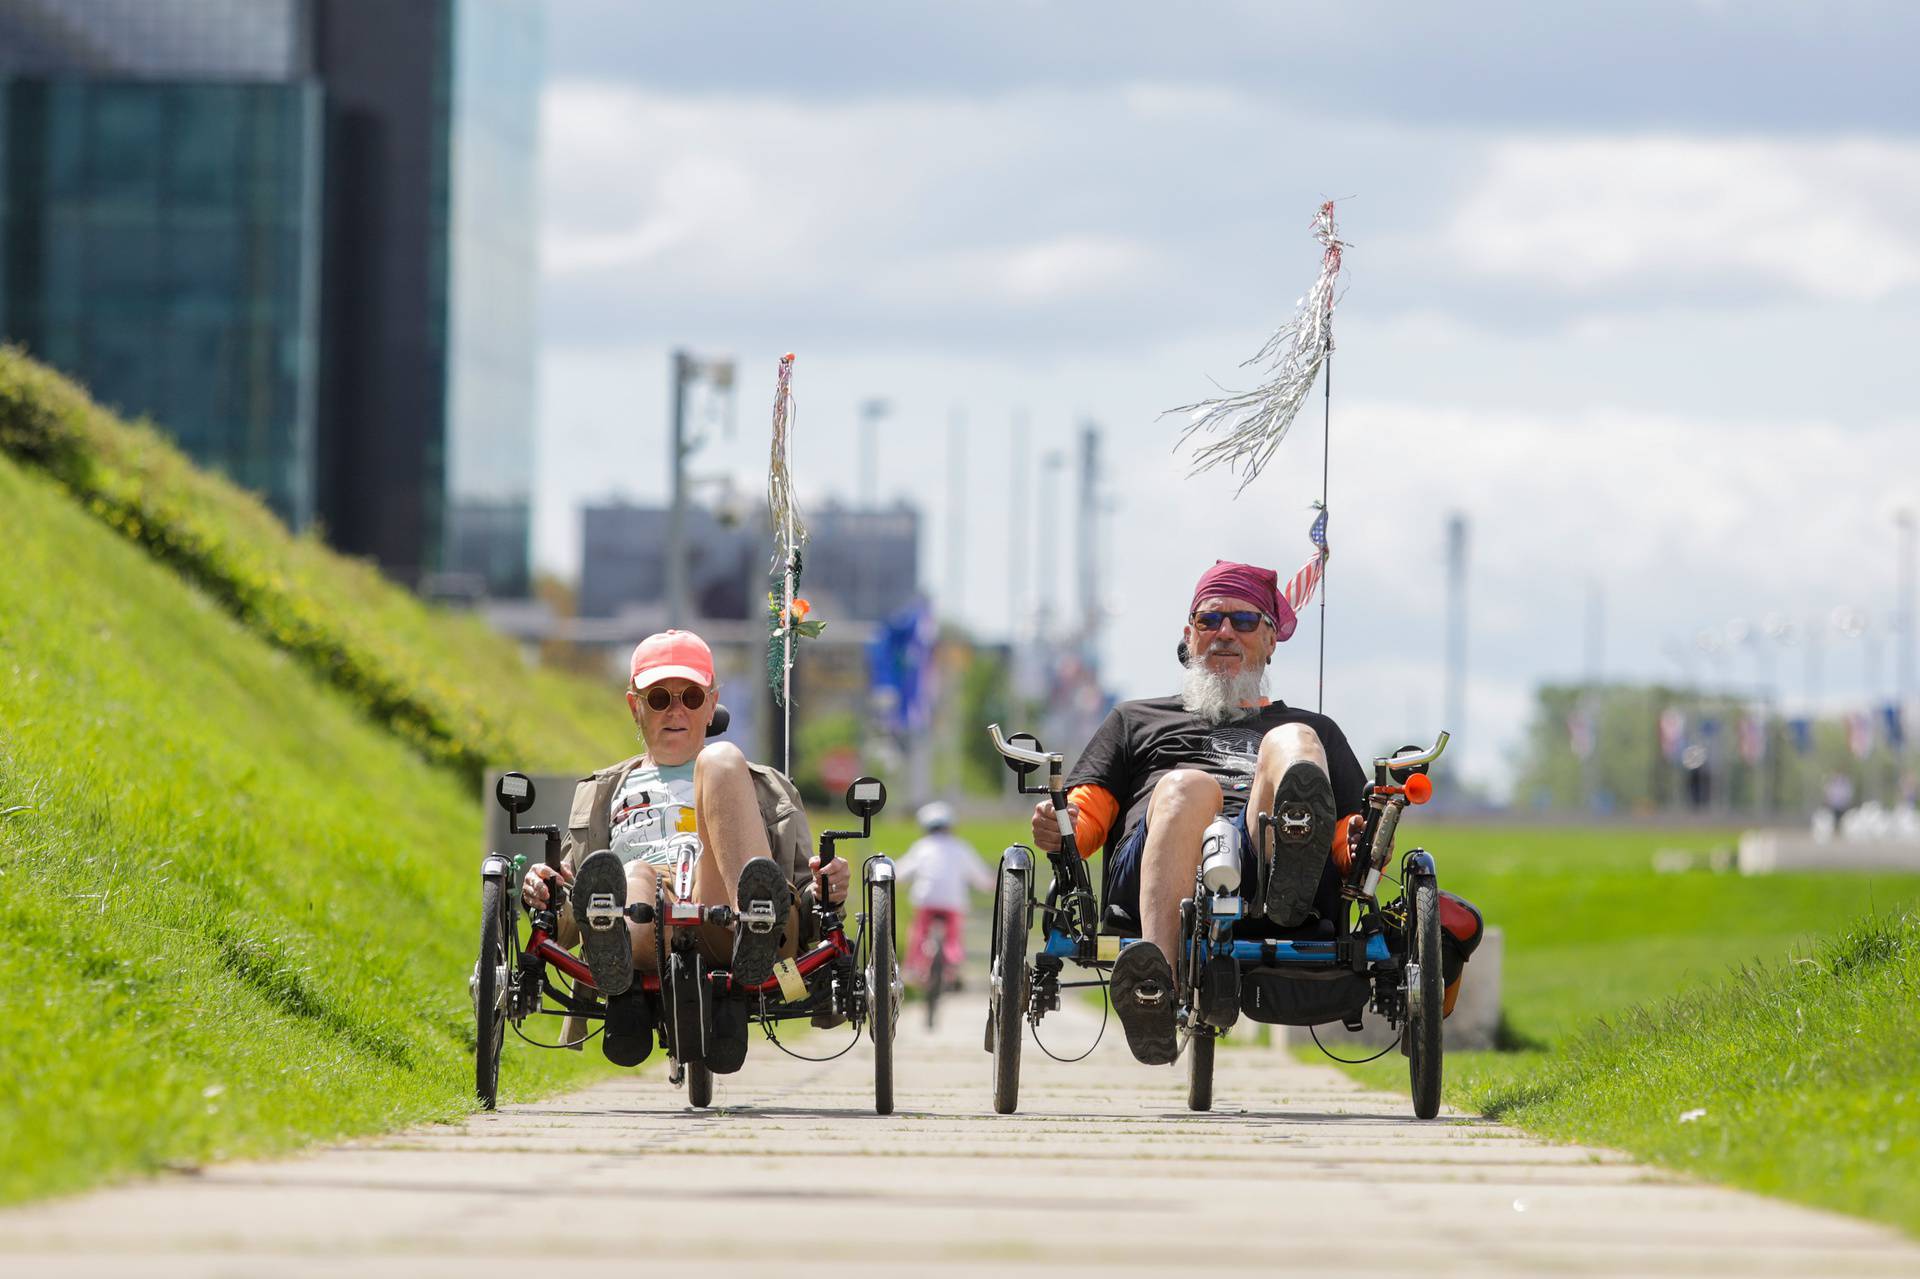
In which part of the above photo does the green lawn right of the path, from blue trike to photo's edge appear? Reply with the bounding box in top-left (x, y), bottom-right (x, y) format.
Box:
top-left (1309, 824), bottom-right (1920, 1231)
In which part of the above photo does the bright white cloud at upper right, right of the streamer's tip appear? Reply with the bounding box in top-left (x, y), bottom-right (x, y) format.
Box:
top-left (1440, 136), bottom-right (1920, 302)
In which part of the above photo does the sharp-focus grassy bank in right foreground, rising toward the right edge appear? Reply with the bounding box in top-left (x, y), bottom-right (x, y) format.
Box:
top-left (1463, 914), bottom-right (1920, 1233)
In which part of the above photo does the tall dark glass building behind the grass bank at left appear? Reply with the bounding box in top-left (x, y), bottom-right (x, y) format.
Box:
top-left (0, 0), bottom-right (541, 597)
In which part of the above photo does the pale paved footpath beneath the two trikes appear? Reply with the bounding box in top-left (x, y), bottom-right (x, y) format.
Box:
top-left (0, 1001), bottom-right (1920, 1279)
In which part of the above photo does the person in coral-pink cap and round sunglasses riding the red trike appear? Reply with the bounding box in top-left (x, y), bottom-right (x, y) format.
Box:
top-left (520, 630), bottom-right (849, 1074)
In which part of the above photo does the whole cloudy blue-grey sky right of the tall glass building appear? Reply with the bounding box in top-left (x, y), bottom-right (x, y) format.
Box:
top-left (536, 0), bottom-right (1920, 785)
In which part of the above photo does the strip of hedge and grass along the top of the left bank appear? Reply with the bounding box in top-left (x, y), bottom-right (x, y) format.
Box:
top-left (0, 348), bottom-right (618, 778)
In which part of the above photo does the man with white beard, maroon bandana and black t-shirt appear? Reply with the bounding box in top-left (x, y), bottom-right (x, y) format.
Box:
top-left (1033, 561), bottom-right (1367, 1064)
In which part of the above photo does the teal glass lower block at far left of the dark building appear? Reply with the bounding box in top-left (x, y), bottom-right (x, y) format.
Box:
top-left (0, 77), bottom-right (321, 528)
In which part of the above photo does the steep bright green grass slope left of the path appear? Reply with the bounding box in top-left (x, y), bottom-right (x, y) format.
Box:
top-left (0, 451), bottom-right (626, 1200)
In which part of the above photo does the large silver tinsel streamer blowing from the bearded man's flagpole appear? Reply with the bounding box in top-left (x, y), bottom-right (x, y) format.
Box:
top-left (1167, 200), bottom-right (1346, 495)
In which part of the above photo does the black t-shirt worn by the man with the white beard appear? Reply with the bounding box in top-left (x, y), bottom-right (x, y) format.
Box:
top-left (1068, 697), bottom-right (1367, 849)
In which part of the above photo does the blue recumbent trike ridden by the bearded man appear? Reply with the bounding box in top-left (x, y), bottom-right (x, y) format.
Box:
top-left (985, 724), bottom-right (1448, 1120)
